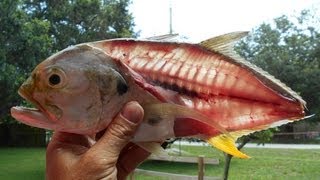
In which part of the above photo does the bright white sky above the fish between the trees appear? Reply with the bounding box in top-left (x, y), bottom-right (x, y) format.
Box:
top-left (129, 0), bottom-right (320, 42)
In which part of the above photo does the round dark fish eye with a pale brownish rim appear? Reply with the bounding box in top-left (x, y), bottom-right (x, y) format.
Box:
top-left (47, 68), bottom-right (66, 88)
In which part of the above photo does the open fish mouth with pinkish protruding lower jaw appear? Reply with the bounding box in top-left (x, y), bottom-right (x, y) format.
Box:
top-left (11, 85), bottom-right (56, 130)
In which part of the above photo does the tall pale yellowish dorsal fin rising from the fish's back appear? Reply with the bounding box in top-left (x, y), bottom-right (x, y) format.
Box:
top-left (200, 31), bottom-right (248, 55)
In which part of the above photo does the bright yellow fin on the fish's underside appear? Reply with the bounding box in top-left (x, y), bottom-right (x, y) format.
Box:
top-left (207, 134), bottom-right (250, 159)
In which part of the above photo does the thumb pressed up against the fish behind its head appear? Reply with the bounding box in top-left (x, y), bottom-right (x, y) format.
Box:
top-left (92, 102), bottom-right (144, 157)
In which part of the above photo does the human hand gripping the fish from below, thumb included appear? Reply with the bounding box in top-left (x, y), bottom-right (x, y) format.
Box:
top-left (46, 102), bottom-right (150, 180)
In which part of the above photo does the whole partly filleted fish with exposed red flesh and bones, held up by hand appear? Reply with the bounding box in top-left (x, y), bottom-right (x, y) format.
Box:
top-left (11, 32), bottom-right (306, 158)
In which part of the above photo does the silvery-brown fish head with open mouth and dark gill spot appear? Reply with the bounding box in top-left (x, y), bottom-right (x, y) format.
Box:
top-left (11, 45), bottom-right (126, 134)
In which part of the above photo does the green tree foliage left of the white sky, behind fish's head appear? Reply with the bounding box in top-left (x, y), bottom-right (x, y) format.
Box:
top-left (0, 0), bottom-right (137, 123)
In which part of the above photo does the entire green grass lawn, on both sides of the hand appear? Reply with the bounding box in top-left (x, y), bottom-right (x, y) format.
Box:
top-left (0, 146), bottom-right (320, 180)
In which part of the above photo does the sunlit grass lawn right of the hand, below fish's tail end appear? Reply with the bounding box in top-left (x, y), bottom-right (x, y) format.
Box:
top-left (140, 146), bottom-right (320, 180)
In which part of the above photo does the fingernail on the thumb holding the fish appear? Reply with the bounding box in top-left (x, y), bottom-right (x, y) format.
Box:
top-left (121, 102), bottom-right (143, 123)
